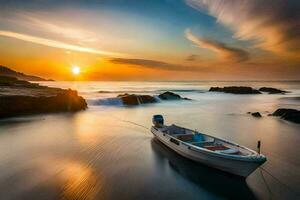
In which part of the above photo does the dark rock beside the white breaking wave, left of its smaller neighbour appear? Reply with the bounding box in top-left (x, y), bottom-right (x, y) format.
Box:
top-left (118, 93), bottom-right (157, 105)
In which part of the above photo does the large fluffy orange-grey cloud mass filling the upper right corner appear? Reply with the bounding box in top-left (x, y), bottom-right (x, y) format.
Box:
top-left (186, 0), bottom-right (300, 58)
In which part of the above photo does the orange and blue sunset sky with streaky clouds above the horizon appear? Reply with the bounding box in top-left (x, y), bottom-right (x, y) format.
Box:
top-left (0, 0), bottom-right (300, 81)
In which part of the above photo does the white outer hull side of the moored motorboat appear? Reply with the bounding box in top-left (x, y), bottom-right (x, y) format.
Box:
top-left (151, 128), bottom-right (265, 177)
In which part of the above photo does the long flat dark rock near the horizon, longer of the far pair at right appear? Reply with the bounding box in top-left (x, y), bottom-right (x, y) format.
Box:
top-left (209, 86), bottom-right (261, 94)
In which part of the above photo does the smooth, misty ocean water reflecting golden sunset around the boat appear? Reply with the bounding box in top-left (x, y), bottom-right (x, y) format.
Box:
top-left (0, 81), bottom-right (300, 199)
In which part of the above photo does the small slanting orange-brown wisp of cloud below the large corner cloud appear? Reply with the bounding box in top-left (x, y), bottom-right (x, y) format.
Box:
top-left (185, 29), bottom-right (249, 62)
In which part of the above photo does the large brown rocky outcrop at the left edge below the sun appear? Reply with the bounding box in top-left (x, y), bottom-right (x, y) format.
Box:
top-left (0, 77), bottom-right (87, 118)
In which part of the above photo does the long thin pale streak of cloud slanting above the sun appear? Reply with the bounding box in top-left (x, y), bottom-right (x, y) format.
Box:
top-left (0, 30), bottom-right (122, 56)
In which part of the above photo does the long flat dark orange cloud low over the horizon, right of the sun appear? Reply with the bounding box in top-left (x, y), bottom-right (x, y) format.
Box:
top-left (110, 58), bottom-right (209, 71)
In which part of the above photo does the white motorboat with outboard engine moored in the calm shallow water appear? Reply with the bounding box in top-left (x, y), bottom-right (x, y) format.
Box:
top-left (151, 115), bottom-right (267, 177)
